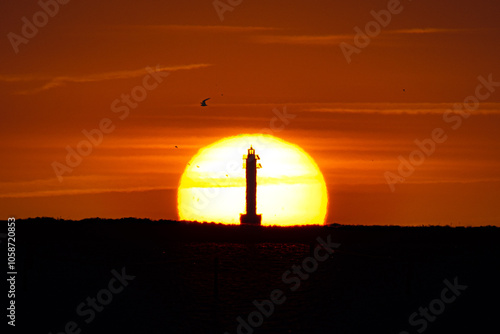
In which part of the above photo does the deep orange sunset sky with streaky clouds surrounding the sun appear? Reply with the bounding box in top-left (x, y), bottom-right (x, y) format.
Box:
top-left (0, 0), bottom-right (500, 226)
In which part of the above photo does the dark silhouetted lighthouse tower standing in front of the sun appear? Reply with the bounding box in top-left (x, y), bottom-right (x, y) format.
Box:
top-left (240, 146), bottom-right (262, 225)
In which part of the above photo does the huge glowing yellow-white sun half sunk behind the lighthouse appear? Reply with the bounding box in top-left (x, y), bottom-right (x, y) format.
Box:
top-left (177, 134), bottom-right (328, 226)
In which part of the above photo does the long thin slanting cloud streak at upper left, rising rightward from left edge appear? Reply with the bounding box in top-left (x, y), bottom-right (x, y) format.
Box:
top-left (0, 64), bottom-right (212, 95)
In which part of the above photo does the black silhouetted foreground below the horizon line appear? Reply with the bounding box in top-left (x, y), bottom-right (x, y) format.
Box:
top-left (2, 219), bottom-right (500, 334)
